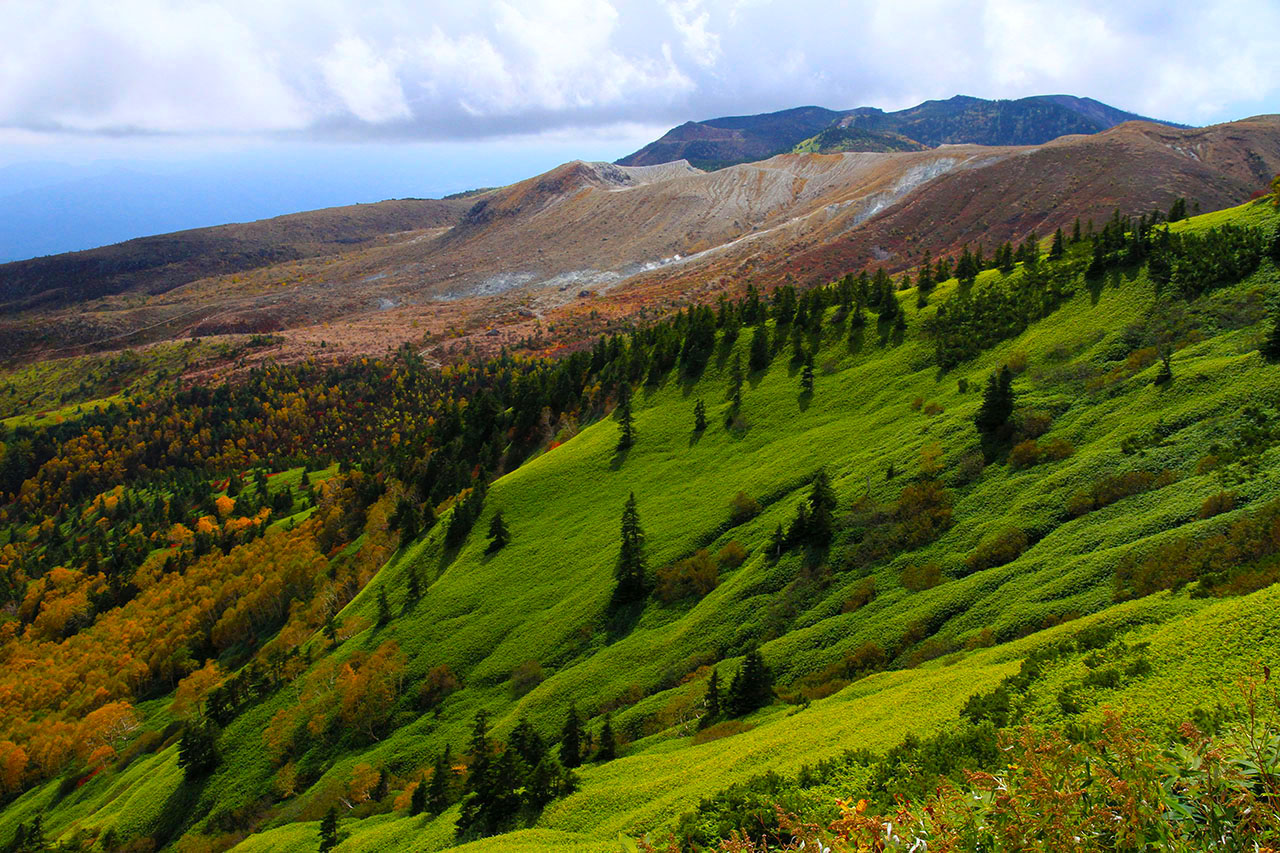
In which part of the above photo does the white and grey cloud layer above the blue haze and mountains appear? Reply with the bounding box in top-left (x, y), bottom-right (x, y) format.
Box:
top-left (0, 0), bottom-right (1280, 140)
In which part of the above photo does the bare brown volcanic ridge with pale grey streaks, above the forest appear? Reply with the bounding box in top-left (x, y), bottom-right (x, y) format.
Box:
top-left (0, 115), bottom-right (1280, 376)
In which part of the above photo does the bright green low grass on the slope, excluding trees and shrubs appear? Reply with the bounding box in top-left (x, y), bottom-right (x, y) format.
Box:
top-left (0, 199), bottom-right (1280, 850)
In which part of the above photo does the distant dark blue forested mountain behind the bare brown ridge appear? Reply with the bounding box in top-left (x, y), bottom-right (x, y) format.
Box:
top-left (618, 95), bottom-right (1177, 169)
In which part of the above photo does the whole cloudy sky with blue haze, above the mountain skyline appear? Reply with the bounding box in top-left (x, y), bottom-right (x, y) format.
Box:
top-left (0, 0), bottom-right (1280, 260)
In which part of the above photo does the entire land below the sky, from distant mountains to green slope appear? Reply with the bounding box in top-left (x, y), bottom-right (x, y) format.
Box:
top-left (0, 16), bottom-right (1280, 853)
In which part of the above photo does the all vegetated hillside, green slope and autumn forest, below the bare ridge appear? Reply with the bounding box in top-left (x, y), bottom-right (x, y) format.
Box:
top-left (0, 192), bottom-right (1280, 850)
